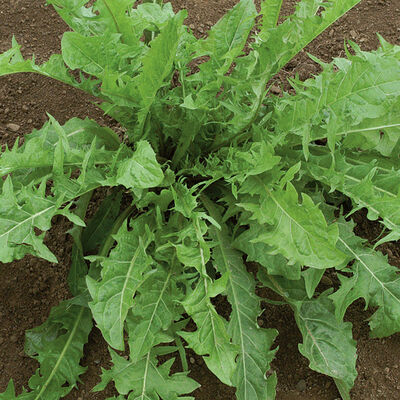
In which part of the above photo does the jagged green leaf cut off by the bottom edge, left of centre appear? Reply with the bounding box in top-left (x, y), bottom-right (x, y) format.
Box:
top-left (94, 348), bottom-right (199, 400)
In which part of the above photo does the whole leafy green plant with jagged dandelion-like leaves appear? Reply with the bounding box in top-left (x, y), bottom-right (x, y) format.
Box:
top-left (0, 0), bottom-right (400, 400)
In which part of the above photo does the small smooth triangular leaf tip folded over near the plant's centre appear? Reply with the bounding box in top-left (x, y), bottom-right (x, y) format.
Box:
top-left (116, 140), bottom-right (164, 189)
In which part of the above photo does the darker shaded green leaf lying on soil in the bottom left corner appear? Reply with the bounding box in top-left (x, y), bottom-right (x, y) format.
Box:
top-left (22, 301), bottom-right (92, 400)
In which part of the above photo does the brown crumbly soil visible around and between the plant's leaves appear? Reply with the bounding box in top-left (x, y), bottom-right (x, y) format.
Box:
top-left (0, 0), bottom-right (400, 400)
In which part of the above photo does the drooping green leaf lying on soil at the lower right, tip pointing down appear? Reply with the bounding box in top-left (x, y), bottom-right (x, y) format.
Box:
top-left (258, 270), bottom-right (357, 400)
